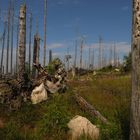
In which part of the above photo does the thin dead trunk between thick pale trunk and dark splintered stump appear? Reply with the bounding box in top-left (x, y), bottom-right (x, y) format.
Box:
top-left (29, 13), bottom-right (32, 73)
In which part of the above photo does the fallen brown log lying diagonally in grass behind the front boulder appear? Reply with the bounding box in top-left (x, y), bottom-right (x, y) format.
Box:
top-left (75, 94), bottom-right (109, 124)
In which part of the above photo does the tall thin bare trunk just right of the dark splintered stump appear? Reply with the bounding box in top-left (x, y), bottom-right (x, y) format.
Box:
top-left (43, 0), bottom-right (47, 66)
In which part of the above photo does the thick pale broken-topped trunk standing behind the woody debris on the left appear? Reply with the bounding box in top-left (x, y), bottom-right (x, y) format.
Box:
top-left (18, 5), bottom-right (26, 80)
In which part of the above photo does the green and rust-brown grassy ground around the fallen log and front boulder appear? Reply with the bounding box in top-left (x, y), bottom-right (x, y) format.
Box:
top-left (0, 73), bottom-right (131, 140)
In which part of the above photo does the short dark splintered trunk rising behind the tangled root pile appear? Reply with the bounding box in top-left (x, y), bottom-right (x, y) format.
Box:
top-left (32, 34), bottom-right (40, 78)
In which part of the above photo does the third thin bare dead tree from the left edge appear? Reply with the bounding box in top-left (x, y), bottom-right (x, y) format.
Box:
top-left (11, 2), bottom-right (14, 74)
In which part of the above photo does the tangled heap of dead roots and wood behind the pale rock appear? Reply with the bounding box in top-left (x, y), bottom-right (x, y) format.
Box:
top-left (0, 60), bottom-right (67, 110)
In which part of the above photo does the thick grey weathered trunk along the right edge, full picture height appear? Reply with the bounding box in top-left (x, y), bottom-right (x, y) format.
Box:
top-left (130, 0), bottom-right (140, 140)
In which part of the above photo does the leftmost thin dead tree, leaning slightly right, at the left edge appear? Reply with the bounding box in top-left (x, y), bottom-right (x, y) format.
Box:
top-left (1, 22), bottom-right (6, 74)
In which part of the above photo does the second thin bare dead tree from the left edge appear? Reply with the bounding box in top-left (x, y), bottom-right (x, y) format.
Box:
top-left (6, 2), bottom-right (11, 74)
